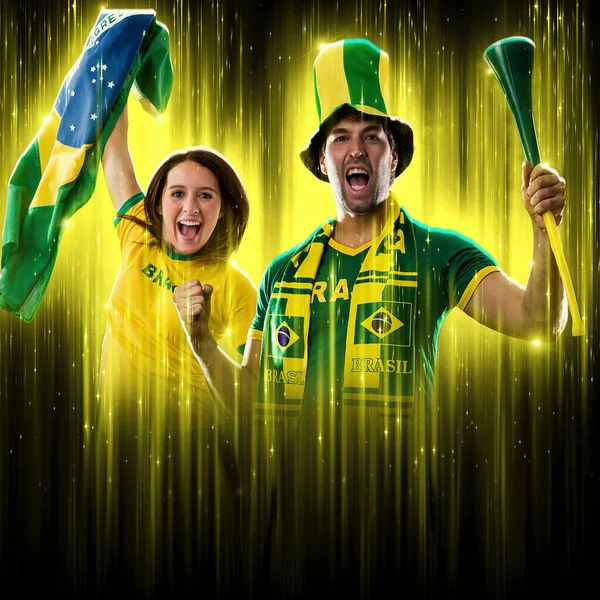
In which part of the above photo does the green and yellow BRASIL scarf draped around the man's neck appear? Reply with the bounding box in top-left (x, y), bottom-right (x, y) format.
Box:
top-left (256, 194), bottom-right (417, 422)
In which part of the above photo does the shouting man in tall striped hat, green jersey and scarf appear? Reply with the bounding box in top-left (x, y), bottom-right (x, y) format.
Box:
top-left (174, 40), bottom-right (567, 424)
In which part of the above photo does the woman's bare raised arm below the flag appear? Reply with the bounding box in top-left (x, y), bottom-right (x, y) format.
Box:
top-left (102, 106), bottom-right (142, 212)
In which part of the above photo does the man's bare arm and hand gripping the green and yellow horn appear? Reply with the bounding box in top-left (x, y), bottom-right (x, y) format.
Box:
top-left (465, 162), bottom-right (567, 341)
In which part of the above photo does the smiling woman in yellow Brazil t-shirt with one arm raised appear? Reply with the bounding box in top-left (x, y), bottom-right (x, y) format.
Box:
top-left (100, 108), bottom-right (256, 433)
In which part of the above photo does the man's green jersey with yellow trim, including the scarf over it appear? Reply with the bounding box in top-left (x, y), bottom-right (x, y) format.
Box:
top-left (250, 196), bottom-right (498, 422)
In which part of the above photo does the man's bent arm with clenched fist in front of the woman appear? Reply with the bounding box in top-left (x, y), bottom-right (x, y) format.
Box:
top-left (173, 279), bottom-right (262, 422)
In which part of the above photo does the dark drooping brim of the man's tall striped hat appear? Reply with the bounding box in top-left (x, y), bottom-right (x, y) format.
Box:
top-left (300, 105), bottom-right (415, 181)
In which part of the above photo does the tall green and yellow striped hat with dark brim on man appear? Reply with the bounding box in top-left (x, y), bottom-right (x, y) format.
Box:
top-left (300, 38), bottom-right (414, 181)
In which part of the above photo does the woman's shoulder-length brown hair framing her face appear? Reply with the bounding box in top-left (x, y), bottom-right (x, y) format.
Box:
top-left (117, 146), bottom-right (250, 262)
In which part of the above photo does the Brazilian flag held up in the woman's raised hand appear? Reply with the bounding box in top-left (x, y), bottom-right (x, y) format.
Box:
top-left (0, 9), bottom-right (173, 323)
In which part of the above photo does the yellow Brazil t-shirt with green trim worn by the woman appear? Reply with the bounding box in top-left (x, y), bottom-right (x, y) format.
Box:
top-left (99, 193), bottom-right (257, 433)
